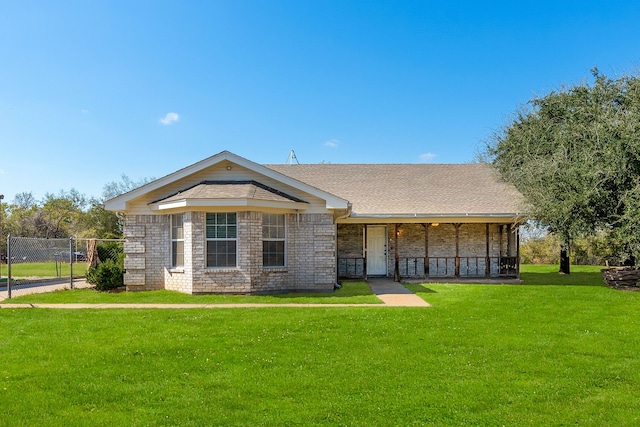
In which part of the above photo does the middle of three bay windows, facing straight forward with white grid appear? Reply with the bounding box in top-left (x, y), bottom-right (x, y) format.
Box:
top-left (206, 213), bottom-right (238, 267)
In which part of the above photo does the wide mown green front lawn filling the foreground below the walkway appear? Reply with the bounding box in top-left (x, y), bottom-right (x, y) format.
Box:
top-left (0, 268), bottom-right (640, 426)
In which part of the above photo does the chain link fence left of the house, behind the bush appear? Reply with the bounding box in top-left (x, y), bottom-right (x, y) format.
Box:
top-left (0, 236), bottom-right (124, 298)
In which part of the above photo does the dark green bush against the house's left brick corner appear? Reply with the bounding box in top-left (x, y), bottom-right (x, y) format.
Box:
top-left (87, 242), bottom-right (124, 291)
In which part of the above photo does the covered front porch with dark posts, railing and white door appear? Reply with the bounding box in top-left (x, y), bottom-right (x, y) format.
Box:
top-left (337, 222), bottom-right (520, 281)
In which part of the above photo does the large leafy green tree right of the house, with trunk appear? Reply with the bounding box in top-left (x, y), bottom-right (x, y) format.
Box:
top-left (483, 69), bottom-right (640, 273)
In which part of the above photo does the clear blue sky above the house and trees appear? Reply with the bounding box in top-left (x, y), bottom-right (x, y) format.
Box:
top-left (0, 0), bottom-right (640, 202)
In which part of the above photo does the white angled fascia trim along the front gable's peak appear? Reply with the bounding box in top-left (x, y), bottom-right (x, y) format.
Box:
top-left (104, 151), bottom-right (349, 211)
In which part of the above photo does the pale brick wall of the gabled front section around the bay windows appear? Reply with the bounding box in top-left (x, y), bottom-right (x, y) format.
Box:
top-left (125, 211), bottom-right (336, 293)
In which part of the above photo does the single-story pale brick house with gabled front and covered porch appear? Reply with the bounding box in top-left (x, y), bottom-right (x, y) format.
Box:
top-left (105, 151), bottom-right (522, 294)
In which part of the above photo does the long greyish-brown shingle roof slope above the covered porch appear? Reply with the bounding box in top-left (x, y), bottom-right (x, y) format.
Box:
top-left (266, 163), bottom-right (523, 216)
